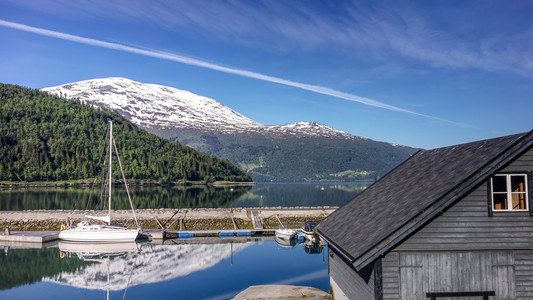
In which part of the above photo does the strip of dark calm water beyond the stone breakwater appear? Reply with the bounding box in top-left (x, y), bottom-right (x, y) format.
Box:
top-left (0, 183), bottom-right (369, 210)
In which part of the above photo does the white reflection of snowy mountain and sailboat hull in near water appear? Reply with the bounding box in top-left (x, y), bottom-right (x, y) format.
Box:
top-left (43, 242), bottom-right (252, 291)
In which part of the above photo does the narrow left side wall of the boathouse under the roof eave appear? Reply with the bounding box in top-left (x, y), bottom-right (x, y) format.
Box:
top-left (328, 248), bottom-right (374, 299)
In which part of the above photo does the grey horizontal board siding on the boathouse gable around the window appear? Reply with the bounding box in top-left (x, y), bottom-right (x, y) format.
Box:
top-left (396, 146), bottom-right (533, 251)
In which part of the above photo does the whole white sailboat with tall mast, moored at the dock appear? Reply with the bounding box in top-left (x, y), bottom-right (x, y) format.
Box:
top-left (59, 121), bottom-right (140, 243)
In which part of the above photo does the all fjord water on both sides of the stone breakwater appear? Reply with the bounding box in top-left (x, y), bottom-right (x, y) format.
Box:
top-left (0, 183), bottom-right (354, 299)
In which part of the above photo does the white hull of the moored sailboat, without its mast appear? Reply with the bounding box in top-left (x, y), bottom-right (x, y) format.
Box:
top-left (59, 226), bottom-right (139, 243)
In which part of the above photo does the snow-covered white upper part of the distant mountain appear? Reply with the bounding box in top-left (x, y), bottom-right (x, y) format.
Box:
top-left (42, 77), bottom-right (360, 139)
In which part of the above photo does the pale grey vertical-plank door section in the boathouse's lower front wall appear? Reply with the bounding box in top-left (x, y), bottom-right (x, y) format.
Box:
top-left (400, 251), bottom-right (516, 299)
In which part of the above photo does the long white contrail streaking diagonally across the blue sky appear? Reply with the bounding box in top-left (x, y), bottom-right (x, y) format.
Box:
top-left (0, 19), bottom-right (469, 127)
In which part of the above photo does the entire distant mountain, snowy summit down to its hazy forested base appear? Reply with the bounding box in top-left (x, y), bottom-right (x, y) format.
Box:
top-left (42, 77), bottom-right (417, 181)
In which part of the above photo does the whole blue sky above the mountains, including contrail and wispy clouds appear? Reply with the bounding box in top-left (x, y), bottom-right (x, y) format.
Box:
top-left (0, 0), bottom-right (533, 149)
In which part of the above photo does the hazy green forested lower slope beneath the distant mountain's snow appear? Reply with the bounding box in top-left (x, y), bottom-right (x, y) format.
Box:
top-left (172, 131), bottom-right (417, 181)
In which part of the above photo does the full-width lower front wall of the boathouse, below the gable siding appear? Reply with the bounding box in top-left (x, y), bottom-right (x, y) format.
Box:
top-left (382, 250), bottom-right (533, 300)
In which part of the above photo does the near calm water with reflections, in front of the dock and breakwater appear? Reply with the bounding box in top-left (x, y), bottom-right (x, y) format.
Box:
top-left (0, 238), bottom-right (329, 299)
